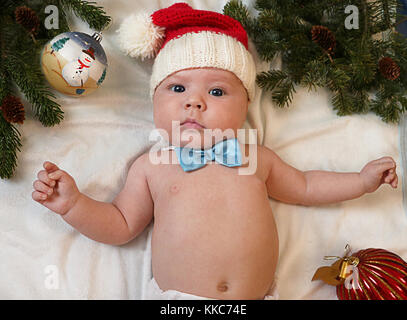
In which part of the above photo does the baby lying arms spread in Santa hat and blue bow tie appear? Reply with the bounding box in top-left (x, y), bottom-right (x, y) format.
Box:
top-left (32, 4), bottom-right (398, 299)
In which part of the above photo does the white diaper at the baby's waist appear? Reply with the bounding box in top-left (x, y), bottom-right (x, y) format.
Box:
top-left (144, 278), bottom-right (278, 300)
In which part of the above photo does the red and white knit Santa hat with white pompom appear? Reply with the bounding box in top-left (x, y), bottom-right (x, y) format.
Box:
top-left (118, 3), bottom-right (256, 101)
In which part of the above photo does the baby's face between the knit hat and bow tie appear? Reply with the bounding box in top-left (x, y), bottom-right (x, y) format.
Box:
top-left (153, 68), bottom-right (248, 148)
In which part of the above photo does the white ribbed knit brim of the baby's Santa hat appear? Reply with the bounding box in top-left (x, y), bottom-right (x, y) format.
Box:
top-left (150, 31), bottom-right (256, 101)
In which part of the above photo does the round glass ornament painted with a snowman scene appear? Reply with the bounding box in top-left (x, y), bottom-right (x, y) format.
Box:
top-left (41, 32), bottom-right (107, 96)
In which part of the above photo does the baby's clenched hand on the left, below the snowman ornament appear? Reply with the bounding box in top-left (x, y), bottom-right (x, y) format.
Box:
top-left (32, 161), bottom-right (80, 215)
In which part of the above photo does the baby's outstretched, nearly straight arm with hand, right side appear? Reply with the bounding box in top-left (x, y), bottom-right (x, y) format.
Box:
top-left (264, 148), bottom-right (398, 205)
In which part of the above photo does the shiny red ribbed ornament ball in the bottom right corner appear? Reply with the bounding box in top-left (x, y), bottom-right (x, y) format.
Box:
top-left (336, 248), bottom-right (407, 300)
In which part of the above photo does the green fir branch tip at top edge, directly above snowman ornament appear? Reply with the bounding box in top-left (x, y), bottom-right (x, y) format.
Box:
top-left (59, 0), bottom-right (112, 31)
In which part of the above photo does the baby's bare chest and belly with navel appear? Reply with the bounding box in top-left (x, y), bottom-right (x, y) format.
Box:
top-left (152, 171), bottom-right (278, 299)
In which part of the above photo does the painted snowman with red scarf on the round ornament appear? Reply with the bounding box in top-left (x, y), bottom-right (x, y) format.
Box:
top-left (62, 47), bottom-right (95, 87)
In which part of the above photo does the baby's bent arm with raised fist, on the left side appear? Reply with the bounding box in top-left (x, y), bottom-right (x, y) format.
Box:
top-left (32, 156), bottom-right (153, 245)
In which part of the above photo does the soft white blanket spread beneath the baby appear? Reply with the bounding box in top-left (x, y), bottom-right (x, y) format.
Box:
top-left (0, 0), bottom-right (407, 299)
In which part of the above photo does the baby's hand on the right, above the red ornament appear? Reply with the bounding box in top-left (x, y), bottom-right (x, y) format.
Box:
top-left (360, 157), bottom-right (398, 193)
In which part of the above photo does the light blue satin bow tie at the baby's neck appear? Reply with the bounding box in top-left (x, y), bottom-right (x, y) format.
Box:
top-left (175, 138), bottom-right (242, 171)
